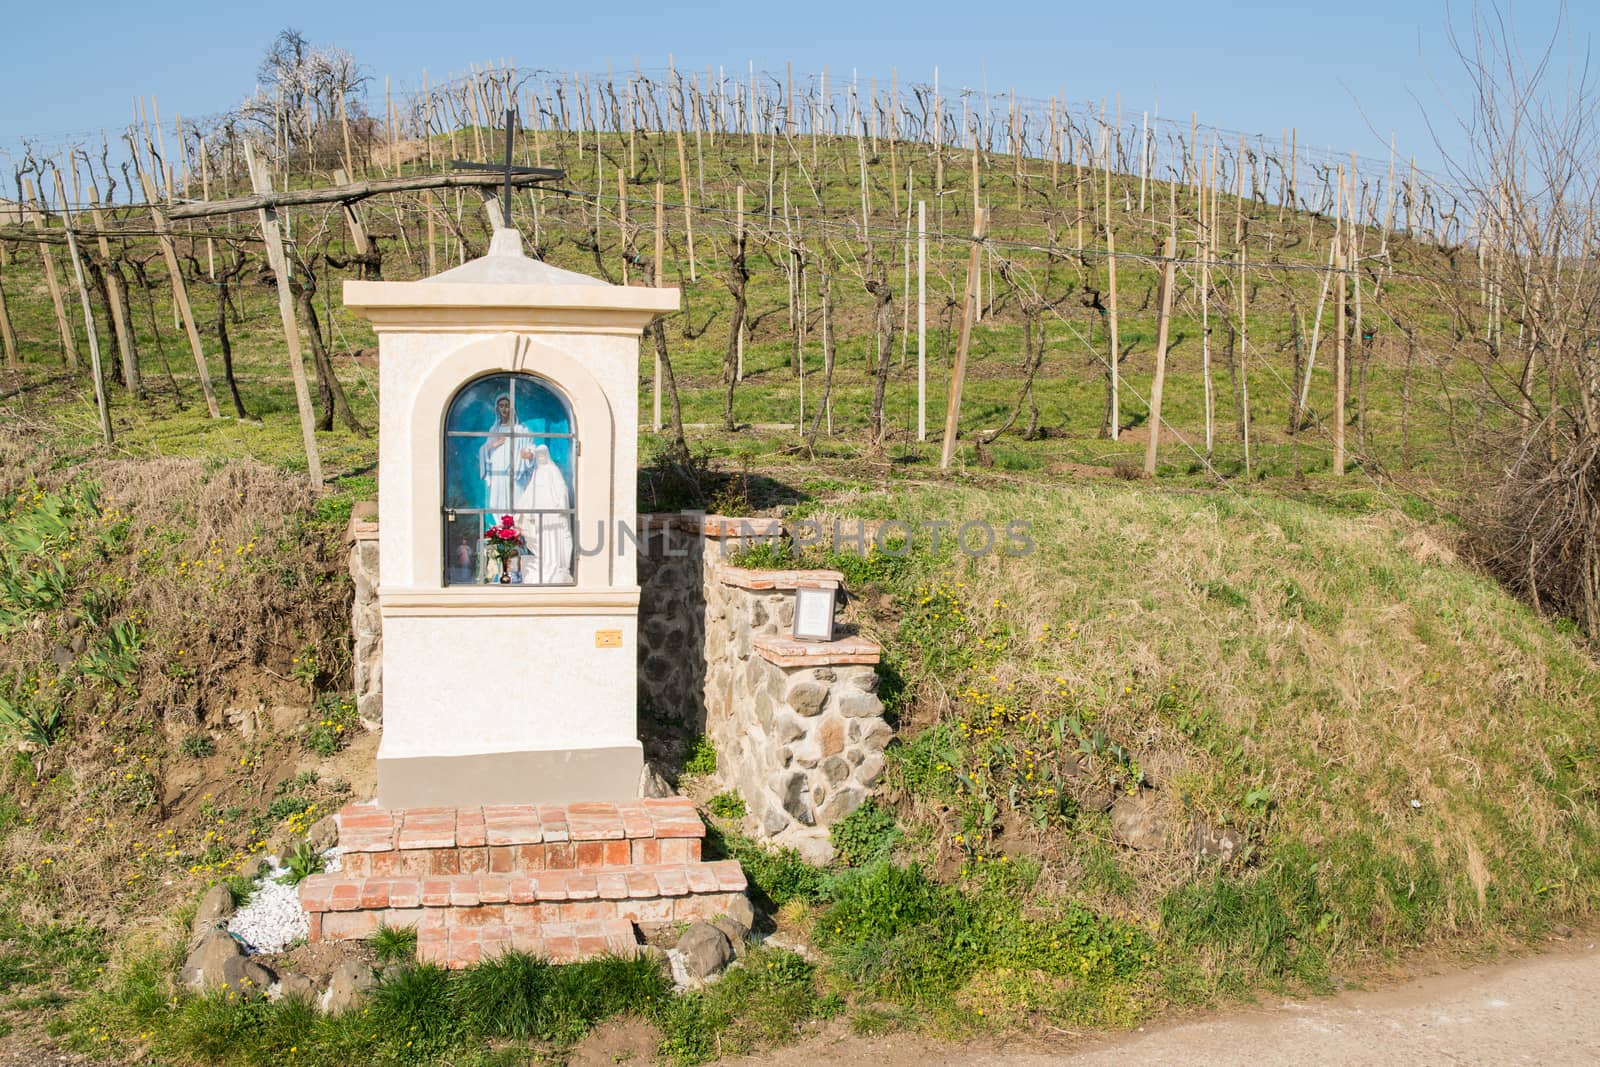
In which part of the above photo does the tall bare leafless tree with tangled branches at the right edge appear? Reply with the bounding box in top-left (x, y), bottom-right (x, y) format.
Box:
top-left (1437, 8), bottom-right (1600, 638)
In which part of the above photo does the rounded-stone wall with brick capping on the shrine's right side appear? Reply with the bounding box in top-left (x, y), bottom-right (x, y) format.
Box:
top-left (638, 515), bottom-right (893, 859)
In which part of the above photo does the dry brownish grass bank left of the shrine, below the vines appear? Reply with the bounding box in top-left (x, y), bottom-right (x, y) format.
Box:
top-left (0, 425), bottom-right (349, 925)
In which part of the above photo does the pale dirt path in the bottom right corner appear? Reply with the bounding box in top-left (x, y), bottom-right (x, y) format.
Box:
top-left (736, 939), bottom-right (1600, 1067)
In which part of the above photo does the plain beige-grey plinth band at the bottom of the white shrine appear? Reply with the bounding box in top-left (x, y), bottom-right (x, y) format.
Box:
top-left (378, 741), bottom-right (645, 808)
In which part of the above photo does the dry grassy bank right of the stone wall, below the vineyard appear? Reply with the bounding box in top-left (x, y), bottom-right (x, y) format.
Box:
top-left (806, 483), bottom-right (1600, 979)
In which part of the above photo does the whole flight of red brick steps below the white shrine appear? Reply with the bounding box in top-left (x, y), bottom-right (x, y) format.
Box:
top-left (299, 797), bottom-right (746, 968)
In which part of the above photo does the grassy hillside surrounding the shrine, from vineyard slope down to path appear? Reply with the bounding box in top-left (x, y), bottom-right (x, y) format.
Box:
top-left (0, 119), bottom-right (1600, 1062)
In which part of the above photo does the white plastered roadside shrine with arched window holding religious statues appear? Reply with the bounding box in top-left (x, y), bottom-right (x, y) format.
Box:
top-left (344, 230), bottom-right (678, 809)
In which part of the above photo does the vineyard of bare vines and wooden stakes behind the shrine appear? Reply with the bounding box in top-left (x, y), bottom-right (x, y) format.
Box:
top-left (0, 55), bottom-right (1523, 492)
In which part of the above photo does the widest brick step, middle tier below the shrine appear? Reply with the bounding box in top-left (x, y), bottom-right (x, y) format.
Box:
top-left (299, 861), bottom-right (746, 941)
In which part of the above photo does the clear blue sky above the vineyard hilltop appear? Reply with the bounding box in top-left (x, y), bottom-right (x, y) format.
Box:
top-left (0, 0), bottom-right (1600, 177)
